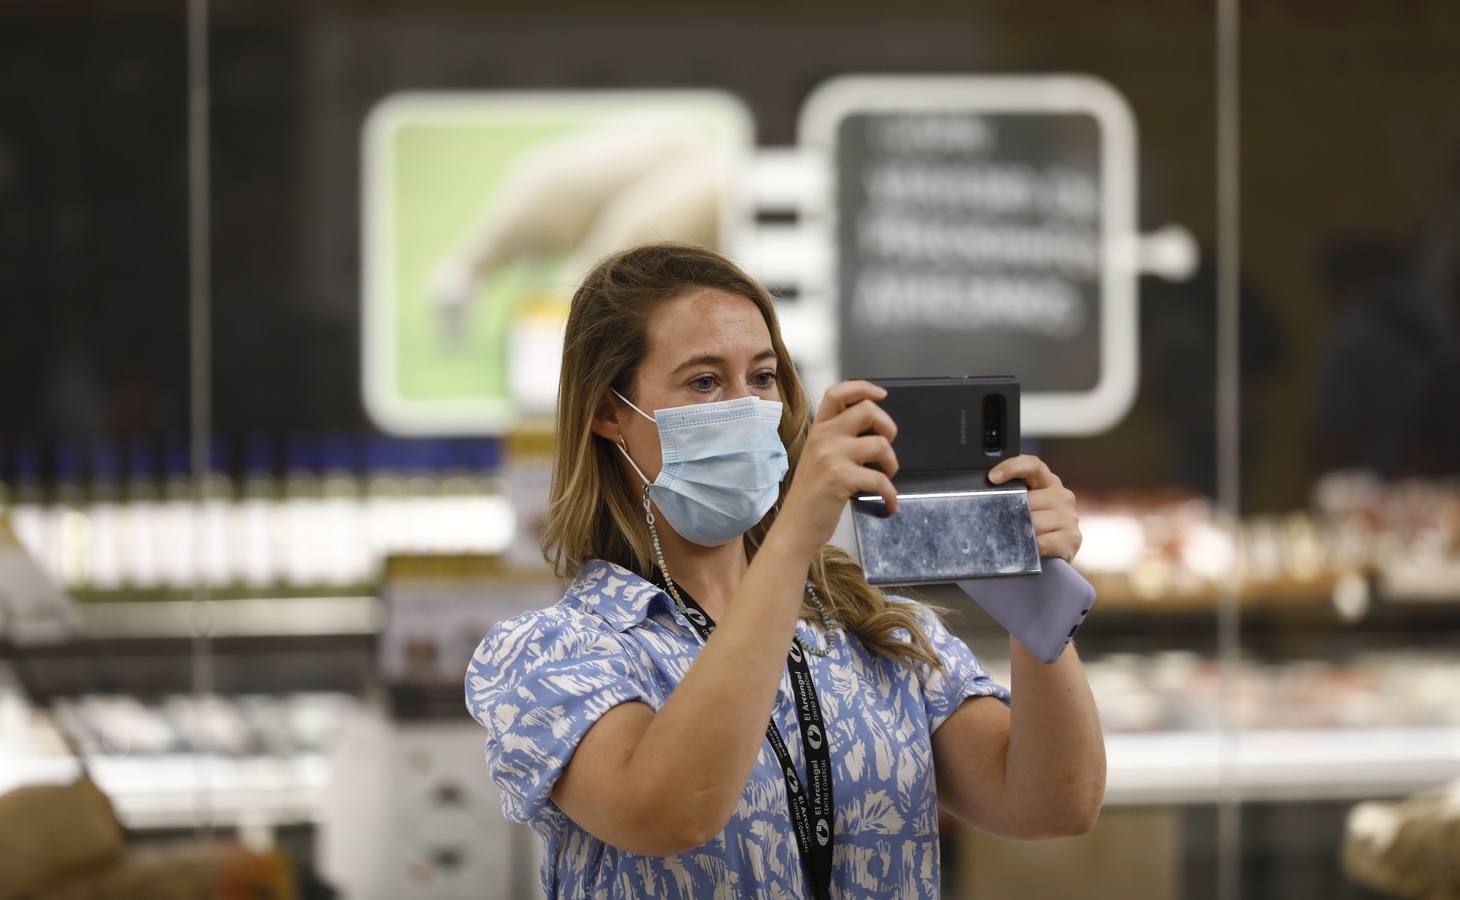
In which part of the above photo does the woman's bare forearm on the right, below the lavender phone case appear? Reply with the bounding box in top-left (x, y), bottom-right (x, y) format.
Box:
top-left (1004, 637), bottom-right (1105, 833)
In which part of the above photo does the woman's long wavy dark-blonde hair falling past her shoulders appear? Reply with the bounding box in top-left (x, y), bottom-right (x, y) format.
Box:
top-left (542, 243), bottom-right (942, 668)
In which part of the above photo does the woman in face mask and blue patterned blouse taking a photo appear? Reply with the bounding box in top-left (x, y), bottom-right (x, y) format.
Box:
top-left (466, 244), bottom-right (1105, 899)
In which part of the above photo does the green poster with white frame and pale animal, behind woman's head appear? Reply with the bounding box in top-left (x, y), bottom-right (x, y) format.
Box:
top-left (362, 91), bottom-right (752, 434)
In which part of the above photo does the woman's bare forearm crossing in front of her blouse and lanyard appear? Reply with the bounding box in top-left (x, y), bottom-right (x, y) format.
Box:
top-left (629, 529), bottom-right (810, 843)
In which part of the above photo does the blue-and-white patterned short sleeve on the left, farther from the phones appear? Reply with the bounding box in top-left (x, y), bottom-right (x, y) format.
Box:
top-left (466, 603), bottom-right (648, 823)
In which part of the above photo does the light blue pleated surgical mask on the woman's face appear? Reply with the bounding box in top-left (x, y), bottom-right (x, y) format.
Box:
top-left (613, 390), bottom-right (788, 546)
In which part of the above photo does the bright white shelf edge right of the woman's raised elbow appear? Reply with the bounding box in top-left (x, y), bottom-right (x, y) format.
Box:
top-left (1105, 728), bottom-right (1460, 806)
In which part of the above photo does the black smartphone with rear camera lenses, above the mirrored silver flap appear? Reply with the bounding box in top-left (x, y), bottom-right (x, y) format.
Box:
top-left (869, 375), bottom-right (1019, 473)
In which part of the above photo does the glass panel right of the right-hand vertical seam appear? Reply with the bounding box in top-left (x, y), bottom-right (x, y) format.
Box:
top-left (1234, 4), bottom-right (1460, 896)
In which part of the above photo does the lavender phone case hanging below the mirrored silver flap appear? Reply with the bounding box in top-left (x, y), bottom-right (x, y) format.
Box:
top-left (958, 557), bottom-right (1095, 663)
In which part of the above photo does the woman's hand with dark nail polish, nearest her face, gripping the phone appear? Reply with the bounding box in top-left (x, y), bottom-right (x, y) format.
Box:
top-left (772, 381), bottom-right (898, 551)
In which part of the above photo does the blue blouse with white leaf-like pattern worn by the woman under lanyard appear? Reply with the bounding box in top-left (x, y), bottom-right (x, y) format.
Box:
top-left (466, 560), bottom-right (1009, 900)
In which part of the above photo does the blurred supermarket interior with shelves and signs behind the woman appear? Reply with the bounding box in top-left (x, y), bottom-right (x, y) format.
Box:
top-left (0, 0), bottom-right (1460, 900)
